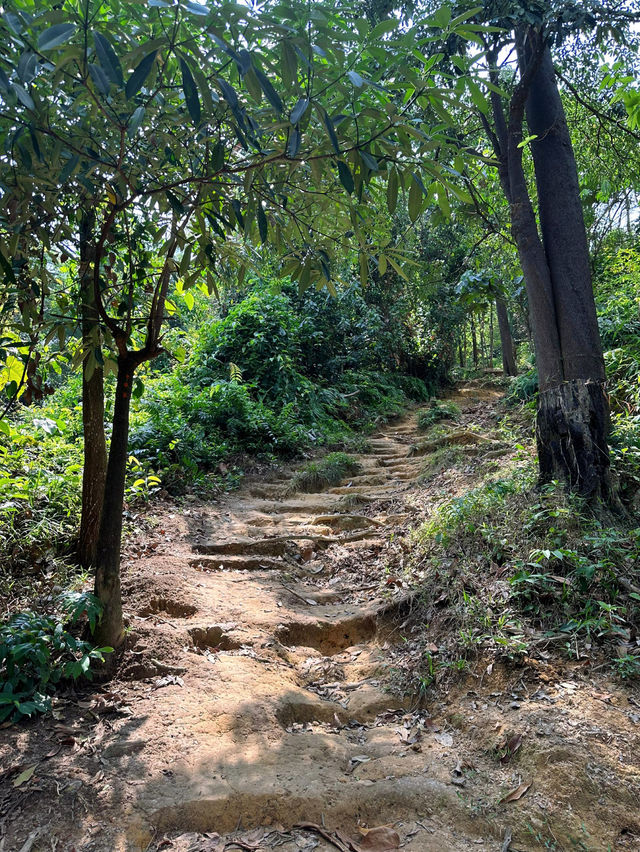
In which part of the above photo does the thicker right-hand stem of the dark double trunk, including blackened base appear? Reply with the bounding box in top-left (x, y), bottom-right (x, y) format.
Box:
top-left (518, 27), bottom-right (615, 500)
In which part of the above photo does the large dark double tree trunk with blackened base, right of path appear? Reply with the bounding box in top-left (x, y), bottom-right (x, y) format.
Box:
top-left (485, 33), bottom-right (617, 505)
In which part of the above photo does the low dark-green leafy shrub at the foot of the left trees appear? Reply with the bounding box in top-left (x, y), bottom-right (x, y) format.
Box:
top-left (0, 592), bottom-right (113, 721)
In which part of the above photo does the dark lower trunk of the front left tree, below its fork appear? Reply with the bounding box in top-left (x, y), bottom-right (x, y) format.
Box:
top-left (95, 356), bottom-right (136, 648)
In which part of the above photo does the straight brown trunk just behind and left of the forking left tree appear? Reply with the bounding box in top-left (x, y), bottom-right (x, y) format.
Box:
top-left (78, 211), bottom-right (107, 568)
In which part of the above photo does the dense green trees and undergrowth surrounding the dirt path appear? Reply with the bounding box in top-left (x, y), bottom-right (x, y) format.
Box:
top-left (0, 2), bottom-right (640, 715)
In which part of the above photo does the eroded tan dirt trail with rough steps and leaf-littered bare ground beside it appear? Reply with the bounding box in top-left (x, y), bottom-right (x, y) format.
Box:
top-left (0, 383), bottom-right (640, 852)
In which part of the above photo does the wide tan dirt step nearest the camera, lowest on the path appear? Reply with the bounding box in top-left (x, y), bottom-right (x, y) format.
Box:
top-left (147, 776), bottom-right (478, 852)
